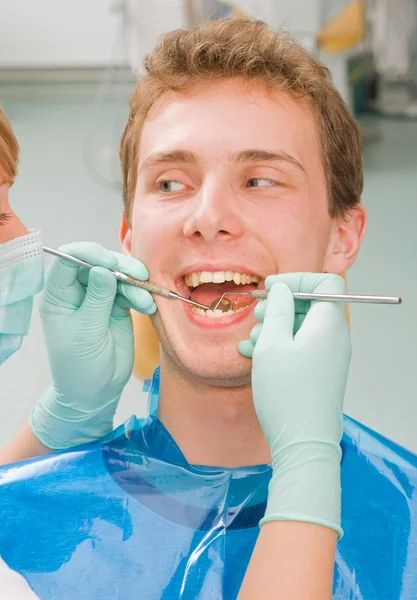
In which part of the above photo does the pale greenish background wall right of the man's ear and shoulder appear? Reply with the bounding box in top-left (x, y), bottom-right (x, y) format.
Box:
top-left (345, 119), bottom-right (417, 452)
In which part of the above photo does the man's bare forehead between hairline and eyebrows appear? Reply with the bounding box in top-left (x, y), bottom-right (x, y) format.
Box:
top-left (139, 80), bottom-right (321, 167)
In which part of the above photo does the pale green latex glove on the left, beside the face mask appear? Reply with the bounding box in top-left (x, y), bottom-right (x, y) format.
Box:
top-left (30, 242), bottom-right (156, 449)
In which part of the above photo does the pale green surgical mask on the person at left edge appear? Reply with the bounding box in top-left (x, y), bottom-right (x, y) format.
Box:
top-left (0, 231), bottom-right (43, 365)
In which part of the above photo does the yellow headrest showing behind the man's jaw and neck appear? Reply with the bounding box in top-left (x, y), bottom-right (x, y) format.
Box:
top-left (132, 275), bottom-right (350, 381)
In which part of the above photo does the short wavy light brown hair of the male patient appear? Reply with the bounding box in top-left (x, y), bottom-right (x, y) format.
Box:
top-left (120, 19), bottom-right (363, 218)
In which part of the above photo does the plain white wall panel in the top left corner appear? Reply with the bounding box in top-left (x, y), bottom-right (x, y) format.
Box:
top-left (0, 0), bottom-right (126, 68)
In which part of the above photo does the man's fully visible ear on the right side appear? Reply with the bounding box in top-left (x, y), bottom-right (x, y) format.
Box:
top-left (323, 205), bottom-right (367, 274)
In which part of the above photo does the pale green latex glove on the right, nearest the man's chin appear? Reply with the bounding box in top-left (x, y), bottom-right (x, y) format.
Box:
top-left (237, 273), bottom-right (351, 537)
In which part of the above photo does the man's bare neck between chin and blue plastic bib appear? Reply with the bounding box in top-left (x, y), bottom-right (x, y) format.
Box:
top-left (158, 360), bottom-right (271, 468)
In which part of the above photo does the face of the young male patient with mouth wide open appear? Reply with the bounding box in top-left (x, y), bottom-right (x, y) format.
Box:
top-left (124, 80), bottom-right (359, 386)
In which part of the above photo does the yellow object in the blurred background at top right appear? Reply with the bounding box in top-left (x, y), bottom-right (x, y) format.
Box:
top-left (317, 1), bottom-right (365, 54)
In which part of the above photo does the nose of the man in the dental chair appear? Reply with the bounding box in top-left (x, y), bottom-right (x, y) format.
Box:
top-left (183, 183), bottom-right (244, 244)
